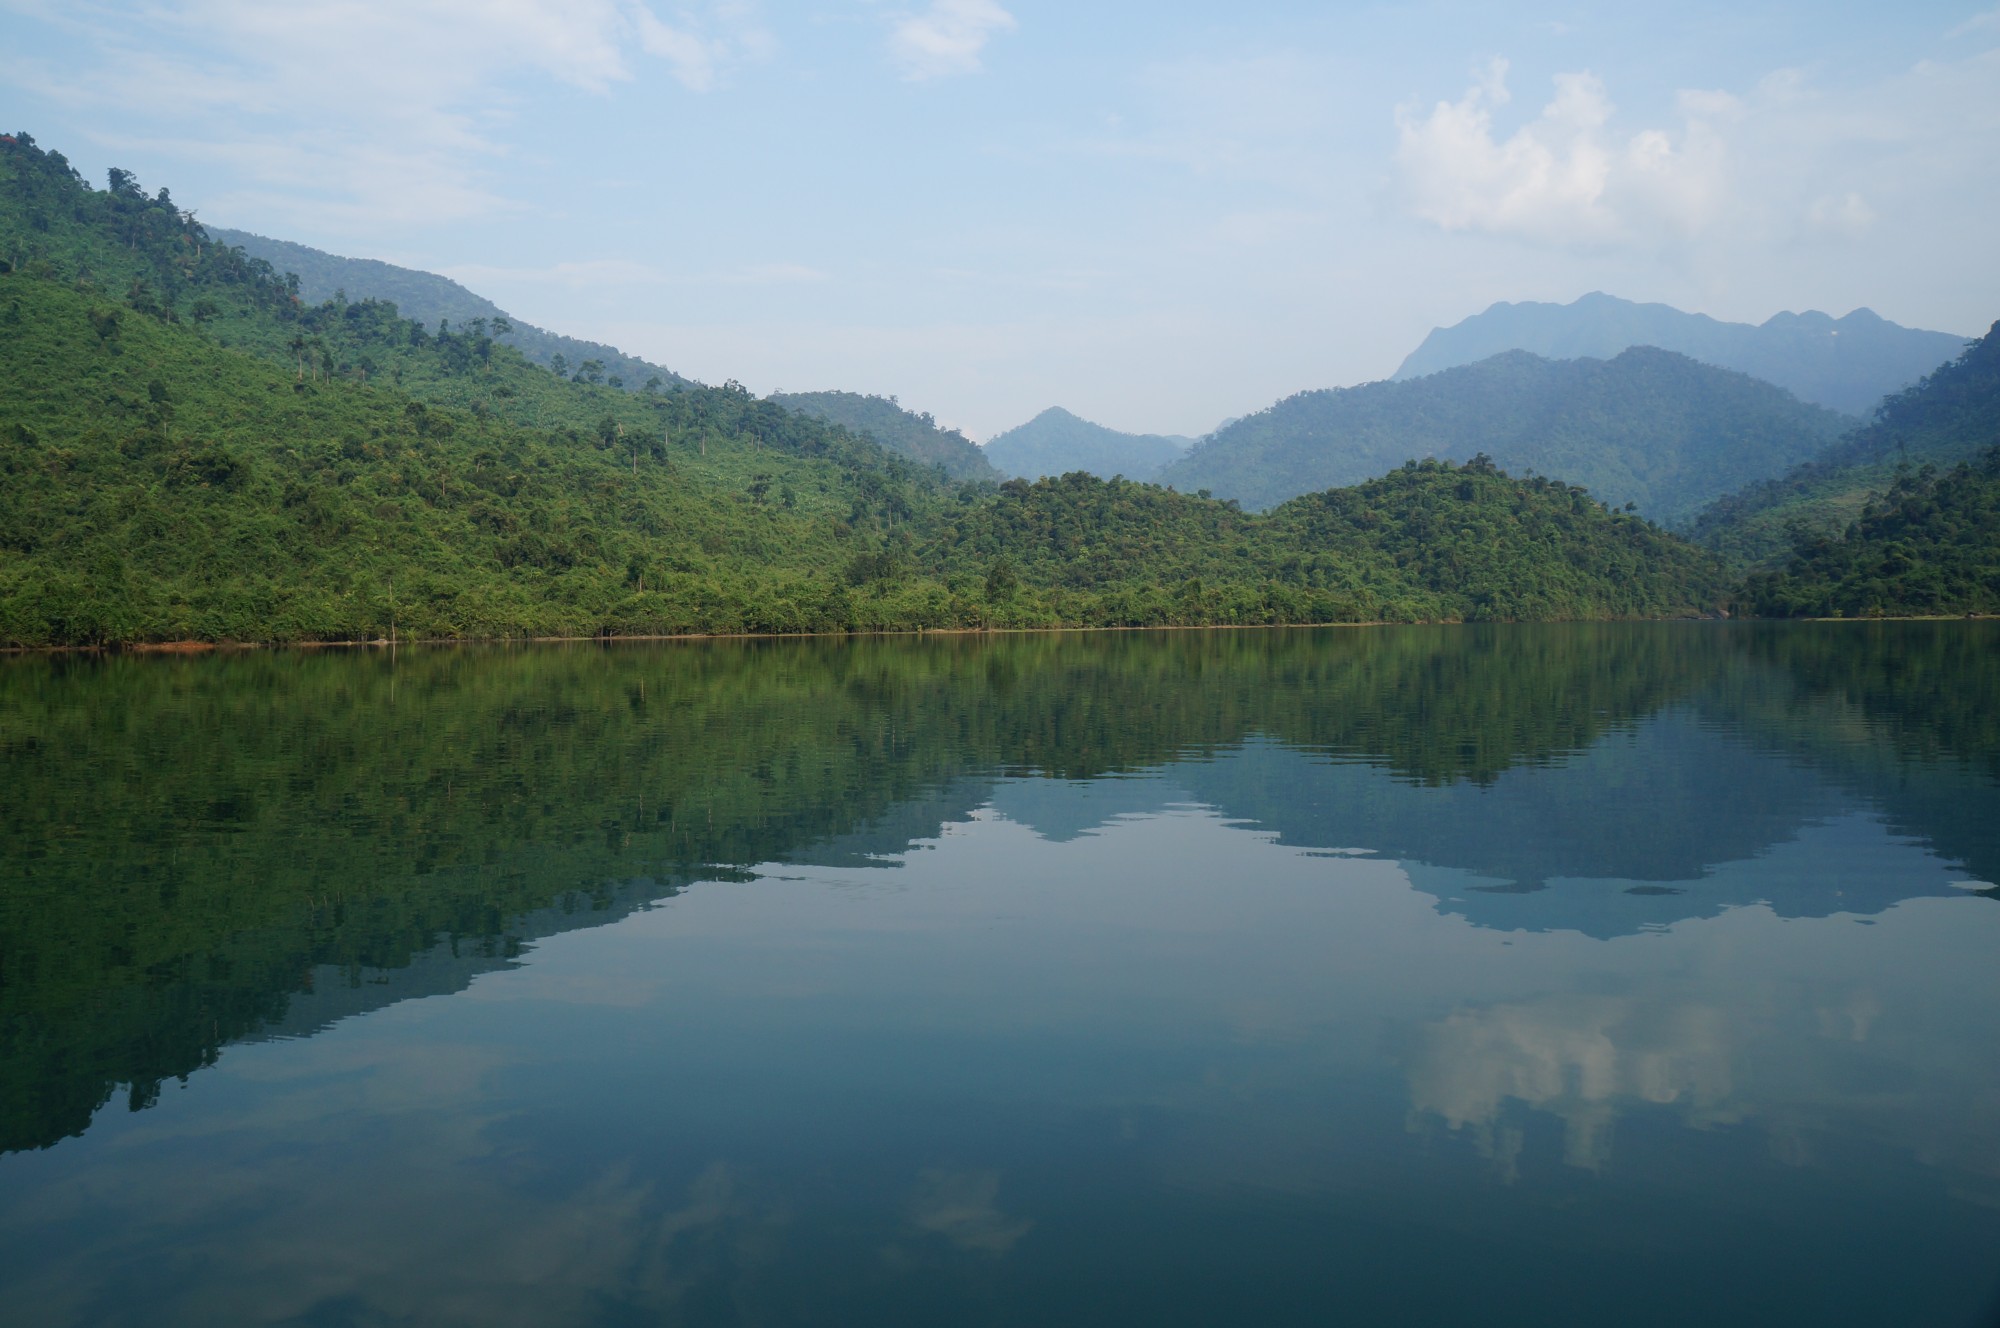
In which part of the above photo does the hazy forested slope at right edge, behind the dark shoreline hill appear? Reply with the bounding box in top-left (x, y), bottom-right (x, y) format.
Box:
top-left (1690, 322), bottom-right (2000, 568)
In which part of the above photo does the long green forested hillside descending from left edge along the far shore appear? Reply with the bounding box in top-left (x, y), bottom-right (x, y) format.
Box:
top-left (0, 134), bottom-right (1722, 646)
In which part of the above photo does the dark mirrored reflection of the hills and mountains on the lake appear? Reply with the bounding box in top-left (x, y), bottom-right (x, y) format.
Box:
top-left (0, 624), bottom-right (2000, 1148)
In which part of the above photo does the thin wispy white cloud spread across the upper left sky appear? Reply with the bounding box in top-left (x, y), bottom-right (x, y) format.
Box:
top-left (4, 0), bottom-right (770, 228)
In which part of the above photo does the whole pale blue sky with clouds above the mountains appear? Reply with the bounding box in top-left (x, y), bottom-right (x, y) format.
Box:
top-left (0, 0), bottom-right (2000, 438)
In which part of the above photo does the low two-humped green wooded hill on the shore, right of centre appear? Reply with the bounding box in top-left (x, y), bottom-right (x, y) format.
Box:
top-left (920, 458), bottom-right (1722, 626)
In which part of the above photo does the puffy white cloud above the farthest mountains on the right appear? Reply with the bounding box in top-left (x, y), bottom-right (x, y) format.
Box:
top-left (1396, 60), bottom-right (1742, 244)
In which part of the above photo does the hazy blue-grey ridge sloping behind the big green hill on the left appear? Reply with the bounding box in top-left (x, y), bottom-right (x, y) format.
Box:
top-left (204, 226), bottom-right (692, 392)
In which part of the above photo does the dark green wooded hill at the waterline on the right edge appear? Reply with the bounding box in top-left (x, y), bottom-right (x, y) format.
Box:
top-left (1742, 448), bottom-right (2000, 618)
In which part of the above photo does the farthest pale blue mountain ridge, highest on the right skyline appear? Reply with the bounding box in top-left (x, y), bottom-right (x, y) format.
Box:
top-left (1394, 290), bottom-right (1970, 416)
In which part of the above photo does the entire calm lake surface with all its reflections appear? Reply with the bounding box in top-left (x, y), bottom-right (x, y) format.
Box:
top-left (0, 624), bottom-right (2000, 1328)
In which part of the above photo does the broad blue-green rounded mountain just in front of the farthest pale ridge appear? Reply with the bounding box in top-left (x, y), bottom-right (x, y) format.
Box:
top-left (1160, 346), bottom-right (1852, 522)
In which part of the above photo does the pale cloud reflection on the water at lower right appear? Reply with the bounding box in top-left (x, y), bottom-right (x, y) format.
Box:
top-left (1408, 900), bottom-right (2000, 1210)
